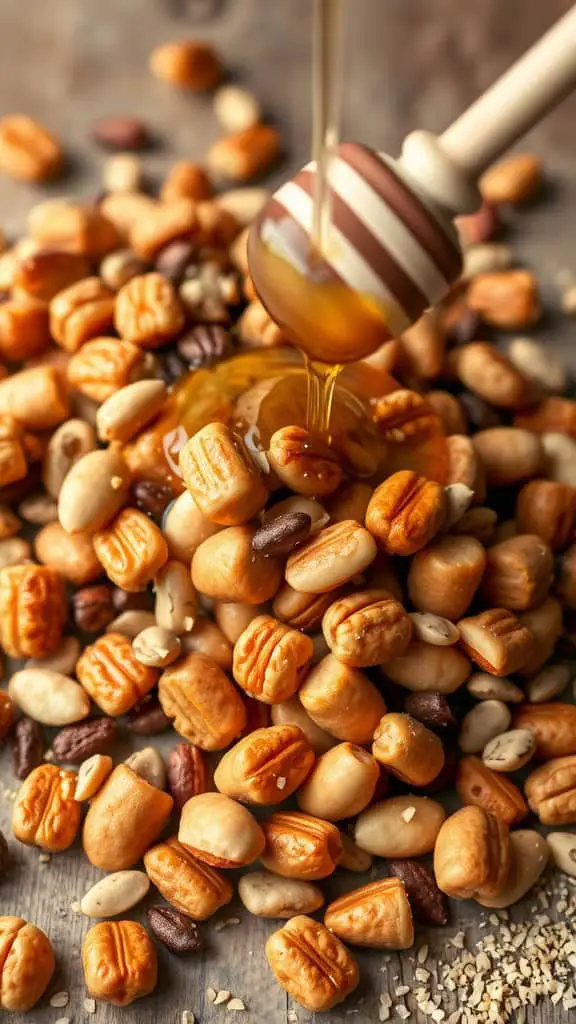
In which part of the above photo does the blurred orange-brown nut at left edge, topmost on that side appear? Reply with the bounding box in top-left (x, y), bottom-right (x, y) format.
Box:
top-left (0, 114), bottom-right (64, 181)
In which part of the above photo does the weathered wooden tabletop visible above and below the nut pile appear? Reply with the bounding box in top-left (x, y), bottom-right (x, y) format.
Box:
top-left (0, 0), bottom-right (576, 1024)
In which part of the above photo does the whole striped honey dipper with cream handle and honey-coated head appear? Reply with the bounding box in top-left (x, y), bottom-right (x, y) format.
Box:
top-left (248, 5), bottom-right (576, 364)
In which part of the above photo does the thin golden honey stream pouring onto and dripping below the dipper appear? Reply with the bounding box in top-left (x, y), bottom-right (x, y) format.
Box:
top-left (304, 0), bottom-right (342, 440)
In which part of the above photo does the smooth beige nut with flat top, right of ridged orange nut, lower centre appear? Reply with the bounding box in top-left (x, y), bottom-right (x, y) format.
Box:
top-left (296, 743), bottom-right (380, 821)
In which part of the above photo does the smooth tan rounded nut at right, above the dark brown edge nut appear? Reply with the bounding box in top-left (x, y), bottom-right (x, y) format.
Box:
top-left (471, 427), bottom-right (544, 486)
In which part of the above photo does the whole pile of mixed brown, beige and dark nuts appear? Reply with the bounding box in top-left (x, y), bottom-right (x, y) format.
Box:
top-left (0, 36), bottom-right (576, 1020)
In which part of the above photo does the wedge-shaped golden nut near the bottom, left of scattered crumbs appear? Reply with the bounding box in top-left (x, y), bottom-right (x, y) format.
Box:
top-left (324, 878), bottom-right (414, 949)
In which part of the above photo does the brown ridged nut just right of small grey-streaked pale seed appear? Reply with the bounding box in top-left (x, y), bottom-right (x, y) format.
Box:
top-left (457, 608), bottom-right (534, 676)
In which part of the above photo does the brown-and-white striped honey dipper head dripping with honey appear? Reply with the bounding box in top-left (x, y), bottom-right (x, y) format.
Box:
top-left (248, 142), bottom-right (461, 362)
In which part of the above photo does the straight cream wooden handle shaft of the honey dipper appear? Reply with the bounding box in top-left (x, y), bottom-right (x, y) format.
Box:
top-left (439, 5), bottom-right (576, 178)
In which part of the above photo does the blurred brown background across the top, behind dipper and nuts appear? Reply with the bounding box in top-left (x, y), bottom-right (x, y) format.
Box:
top-left (0, 0), bottom-right (576, 230)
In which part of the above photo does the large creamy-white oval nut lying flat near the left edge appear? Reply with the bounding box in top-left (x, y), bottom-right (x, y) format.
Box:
top-left (8, 669), bottom-right (90, 727)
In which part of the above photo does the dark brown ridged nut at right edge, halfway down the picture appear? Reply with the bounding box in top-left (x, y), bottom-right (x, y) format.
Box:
top-left (516, 480), bottom-right (576, 551)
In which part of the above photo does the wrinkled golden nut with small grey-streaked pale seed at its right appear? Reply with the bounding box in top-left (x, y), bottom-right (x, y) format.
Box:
top-left (322, 590), bottom-right (412, 669)
